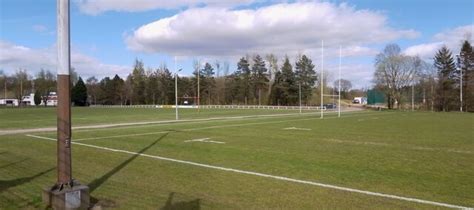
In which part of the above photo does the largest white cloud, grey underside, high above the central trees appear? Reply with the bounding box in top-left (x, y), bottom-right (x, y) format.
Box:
top-left (125, 2), bottom-right (418, 56)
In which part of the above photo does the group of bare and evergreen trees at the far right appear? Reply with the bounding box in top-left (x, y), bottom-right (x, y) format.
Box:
top-left (374, 40), bottom-right (474, 112)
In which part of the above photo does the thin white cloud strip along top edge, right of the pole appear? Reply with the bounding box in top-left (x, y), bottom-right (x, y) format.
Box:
top-left (76, 0), bottom-right (255, 15)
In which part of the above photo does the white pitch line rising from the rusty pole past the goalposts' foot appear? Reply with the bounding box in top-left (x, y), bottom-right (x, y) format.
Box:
top-left (73, 113), bottom-right (391, 141)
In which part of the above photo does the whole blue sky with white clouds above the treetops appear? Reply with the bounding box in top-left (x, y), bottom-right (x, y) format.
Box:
top-left (0, 0), bottom-right (474, 87)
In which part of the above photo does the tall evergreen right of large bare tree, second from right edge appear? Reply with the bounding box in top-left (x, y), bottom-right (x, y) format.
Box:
top-left (434, 46), bottom-right (456, 111)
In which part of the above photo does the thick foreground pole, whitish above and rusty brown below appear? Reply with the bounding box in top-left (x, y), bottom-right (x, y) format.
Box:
top-left (57, 0), bottom-right (72, 188)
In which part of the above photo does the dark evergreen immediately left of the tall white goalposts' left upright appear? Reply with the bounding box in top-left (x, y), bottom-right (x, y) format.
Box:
top-left (295, 55), bottom-right (317, 104)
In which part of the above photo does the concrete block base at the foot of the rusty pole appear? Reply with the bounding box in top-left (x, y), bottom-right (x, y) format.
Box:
top-left (42, 184), bottom-right (90, 210)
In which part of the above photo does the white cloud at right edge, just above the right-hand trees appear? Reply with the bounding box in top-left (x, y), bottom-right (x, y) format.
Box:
top-left (404, 25), bottom-right (474, 59)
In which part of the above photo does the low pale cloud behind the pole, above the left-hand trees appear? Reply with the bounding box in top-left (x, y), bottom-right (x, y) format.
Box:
top-left (0, 40), bottom-right (131, 77)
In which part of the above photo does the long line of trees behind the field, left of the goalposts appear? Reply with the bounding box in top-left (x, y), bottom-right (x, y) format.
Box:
top-left (0, 54), bottom-right (358, 105)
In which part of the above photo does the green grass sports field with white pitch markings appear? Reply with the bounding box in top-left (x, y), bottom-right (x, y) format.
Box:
top-left (0, 108), bottom-right (474, 209)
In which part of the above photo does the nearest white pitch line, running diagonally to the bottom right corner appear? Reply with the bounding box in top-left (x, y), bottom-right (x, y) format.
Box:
top-left (26, 134), bottom-right (472, 209)
